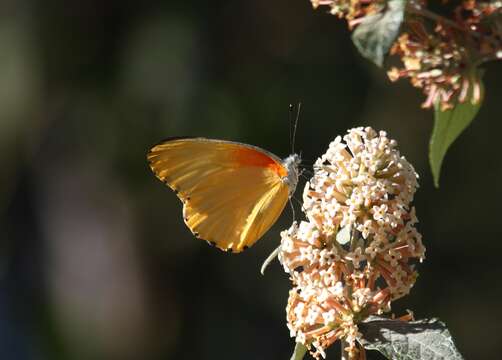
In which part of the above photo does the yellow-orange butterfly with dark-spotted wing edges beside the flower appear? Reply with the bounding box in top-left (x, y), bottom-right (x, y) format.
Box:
top-left (147, 137), bottom-right (301, 252)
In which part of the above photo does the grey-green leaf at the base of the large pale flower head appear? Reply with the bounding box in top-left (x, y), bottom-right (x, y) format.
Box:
top-left (358, 316), bottom-right (463, 360)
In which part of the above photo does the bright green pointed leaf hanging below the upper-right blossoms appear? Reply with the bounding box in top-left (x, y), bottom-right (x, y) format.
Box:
top-left (429, 72), bottom-right (484, 187)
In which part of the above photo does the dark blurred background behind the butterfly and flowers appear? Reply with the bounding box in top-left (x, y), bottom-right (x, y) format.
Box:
top-left (0, 0), bottom-right (502, 360)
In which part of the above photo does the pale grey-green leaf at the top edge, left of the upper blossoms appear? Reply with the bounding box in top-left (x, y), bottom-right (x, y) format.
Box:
top-left (352, 0), bottom-right (408, 67)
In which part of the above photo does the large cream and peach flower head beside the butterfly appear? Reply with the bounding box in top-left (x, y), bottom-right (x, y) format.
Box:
top-left (279, 128), bottom-right (425, 359)
